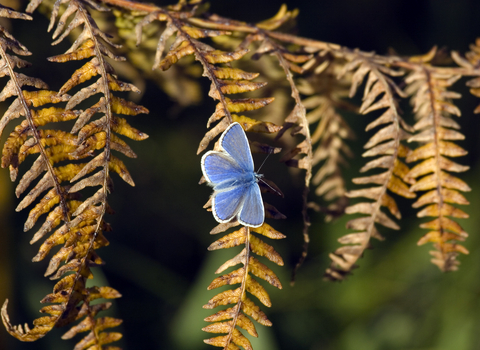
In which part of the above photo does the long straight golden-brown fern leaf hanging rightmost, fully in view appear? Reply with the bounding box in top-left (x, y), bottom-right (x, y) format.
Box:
top-left (404, 57), bottom-right (470, 271)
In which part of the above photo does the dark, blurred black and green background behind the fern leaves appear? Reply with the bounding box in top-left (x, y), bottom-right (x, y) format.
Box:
top-left (0, 0), bottom-right (480, 350)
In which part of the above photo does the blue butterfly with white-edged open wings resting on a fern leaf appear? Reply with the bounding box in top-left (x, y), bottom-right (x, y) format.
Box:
top-left (202, 123), bottom-right (265, 227)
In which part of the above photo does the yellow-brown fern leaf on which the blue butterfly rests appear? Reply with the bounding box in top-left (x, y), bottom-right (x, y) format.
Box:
top-left (132, 8), bottom-right (284, 349)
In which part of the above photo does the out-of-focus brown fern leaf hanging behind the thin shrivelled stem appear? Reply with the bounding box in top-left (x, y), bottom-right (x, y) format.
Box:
top-left (299, 54), bottom-right (358, 222)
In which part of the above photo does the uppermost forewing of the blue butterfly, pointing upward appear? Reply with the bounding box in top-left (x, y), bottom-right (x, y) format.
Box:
top-left (220, 123), bottom-right (254, 172)
